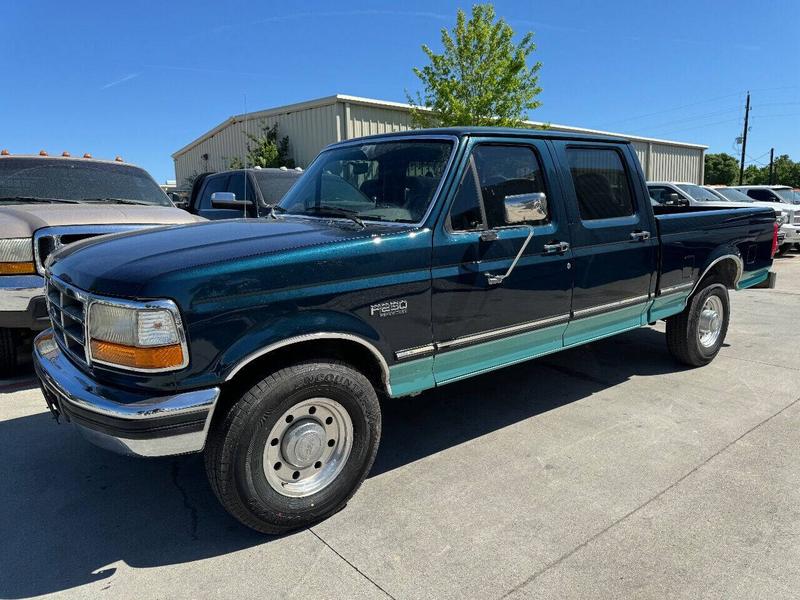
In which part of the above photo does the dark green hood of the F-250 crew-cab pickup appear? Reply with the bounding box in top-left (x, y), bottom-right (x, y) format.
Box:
top-left (50, 218), bottom-right (410, 297)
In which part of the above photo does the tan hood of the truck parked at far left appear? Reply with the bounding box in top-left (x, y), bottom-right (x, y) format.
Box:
top-left (0, 204), bottom-right (204, 239)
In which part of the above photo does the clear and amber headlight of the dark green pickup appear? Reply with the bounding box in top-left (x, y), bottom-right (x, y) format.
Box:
top-left (89, 300), bottom-right (189, 371)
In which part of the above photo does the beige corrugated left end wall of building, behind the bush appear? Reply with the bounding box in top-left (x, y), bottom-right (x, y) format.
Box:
top-left (175, 103), bottom-right (340, 186)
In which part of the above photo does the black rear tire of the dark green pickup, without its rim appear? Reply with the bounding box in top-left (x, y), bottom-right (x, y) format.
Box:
top-left (667, 283), bottom-right (730, 367)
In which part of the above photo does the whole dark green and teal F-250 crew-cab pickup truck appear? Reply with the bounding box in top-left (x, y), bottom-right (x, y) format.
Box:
top-left (34, 128), bottom-right (777, 533)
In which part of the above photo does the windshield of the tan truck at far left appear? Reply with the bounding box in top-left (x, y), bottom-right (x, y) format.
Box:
top-left (0, 158), bottom-right (172, 206)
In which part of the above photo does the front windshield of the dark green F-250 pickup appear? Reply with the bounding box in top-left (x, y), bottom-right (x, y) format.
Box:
top-left (279, 140), bottom-right (453, 223)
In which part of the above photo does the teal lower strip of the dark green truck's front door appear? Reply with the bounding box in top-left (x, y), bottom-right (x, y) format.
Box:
top-left (433, 324), bottom-right (567, 385)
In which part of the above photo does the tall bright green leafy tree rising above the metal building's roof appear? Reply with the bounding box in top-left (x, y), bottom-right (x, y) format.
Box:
top-left (406, 4), bottom-right (542, 127)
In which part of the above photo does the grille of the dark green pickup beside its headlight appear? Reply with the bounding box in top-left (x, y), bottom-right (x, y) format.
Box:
top-left (46, 277), bottom-right (88, 364)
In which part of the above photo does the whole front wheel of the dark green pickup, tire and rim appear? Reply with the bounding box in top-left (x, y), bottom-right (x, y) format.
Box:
top-left (205, 361), bottom-right (381, 534)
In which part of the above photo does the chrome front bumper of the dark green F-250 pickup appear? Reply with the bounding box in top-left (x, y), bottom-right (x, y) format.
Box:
top-left (33, 330), bottom-right (220, 456)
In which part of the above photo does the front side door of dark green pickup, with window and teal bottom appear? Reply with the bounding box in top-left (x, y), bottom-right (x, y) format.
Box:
top-left (432, 138), bottom-right (572, 383)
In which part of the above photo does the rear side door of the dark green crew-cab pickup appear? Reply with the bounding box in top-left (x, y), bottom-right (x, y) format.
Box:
top-left (555, 141), bottom-right (658, 346)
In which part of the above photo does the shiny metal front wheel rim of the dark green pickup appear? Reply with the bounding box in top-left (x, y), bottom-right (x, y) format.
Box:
top-left (263, 398), bottom-right (353, 498)
